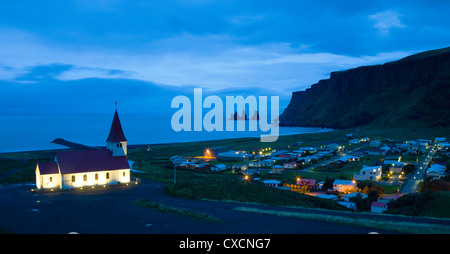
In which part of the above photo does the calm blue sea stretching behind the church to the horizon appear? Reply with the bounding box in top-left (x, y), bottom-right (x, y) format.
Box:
top-left (0, 112), bottom-right (332, 153)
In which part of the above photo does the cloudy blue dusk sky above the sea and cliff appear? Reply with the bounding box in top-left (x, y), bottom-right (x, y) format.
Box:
top-left (0, 0), bottom-right (450, 114)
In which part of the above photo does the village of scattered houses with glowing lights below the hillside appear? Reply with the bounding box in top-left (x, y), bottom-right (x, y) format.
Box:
top-left (168, 133), bottom-right (450, 213)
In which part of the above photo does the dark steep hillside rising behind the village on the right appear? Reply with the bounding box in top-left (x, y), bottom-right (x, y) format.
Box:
top-left (280, 47), bottom-right (450, 129)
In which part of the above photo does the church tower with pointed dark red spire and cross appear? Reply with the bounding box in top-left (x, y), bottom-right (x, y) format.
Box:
top-left (106, 109), bottom-right (127, 157)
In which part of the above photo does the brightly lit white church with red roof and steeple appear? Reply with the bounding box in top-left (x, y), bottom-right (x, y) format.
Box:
top-left (35, 109), bottom-right (130, 189)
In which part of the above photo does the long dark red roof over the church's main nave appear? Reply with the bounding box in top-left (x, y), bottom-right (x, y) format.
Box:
top-left (56, 149), bottom-right (130, 174)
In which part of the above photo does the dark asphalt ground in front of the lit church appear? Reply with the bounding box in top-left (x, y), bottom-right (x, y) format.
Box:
top-left (0, 180), bottom-right (450, 234)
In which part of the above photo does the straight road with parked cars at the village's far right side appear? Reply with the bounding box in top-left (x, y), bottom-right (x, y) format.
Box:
top-left (399, 143), bottom-right (437, 193)
